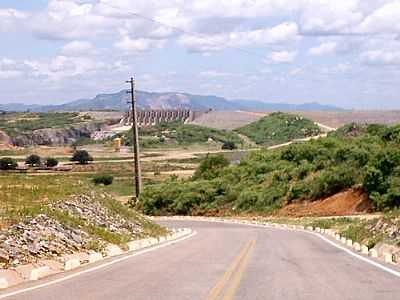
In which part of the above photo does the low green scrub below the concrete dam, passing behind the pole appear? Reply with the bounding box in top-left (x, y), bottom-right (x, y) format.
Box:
top-left (122, 122), bottom-right (242, 148)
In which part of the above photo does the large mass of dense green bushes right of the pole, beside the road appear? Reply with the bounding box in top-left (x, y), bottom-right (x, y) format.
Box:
top-left (138, 125), bottom-right (400, 214)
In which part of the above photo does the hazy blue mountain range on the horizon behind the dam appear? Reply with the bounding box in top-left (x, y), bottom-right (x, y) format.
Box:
top-left (0, 90), bottom-right (342, 112)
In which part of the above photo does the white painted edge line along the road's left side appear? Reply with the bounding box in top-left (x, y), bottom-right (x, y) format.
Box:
top-left (0, 231), bottom-right (197, 299)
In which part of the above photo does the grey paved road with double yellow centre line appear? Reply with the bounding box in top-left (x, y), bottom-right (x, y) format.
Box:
top-left (0, 222), bottom-right (400, 300)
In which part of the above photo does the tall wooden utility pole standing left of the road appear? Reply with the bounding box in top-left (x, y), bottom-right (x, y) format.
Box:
top-left (126, 77), bottom-right (142, 201)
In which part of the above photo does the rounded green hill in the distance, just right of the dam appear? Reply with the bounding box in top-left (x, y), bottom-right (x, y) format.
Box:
top-left (236, 112), bottom-right (321, 146)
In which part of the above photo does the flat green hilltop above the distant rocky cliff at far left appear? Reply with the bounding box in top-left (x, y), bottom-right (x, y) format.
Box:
top-left (0, 112), bottom-right (91, 137)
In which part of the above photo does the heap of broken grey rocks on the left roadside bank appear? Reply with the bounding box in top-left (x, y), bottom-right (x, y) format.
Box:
top-left (0, 195), bottom-right (147, 269)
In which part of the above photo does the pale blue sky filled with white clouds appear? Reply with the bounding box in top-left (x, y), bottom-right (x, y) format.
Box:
top-left (0, 0), bottom-right (400, 109)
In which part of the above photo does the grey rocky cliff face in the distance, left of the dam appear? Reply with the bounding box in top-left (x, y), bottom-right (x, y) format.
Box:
top-left (12, 122), bottom-right (106, 147)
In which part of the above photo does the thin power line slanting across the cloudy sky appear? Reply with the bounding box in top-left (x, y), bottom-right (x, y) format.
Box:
top-left (106, 3), bottom-right (265, 59)
